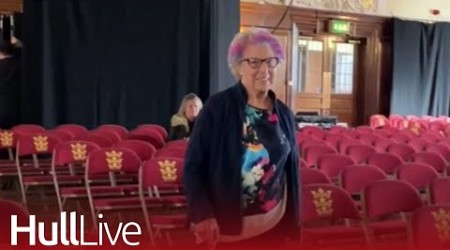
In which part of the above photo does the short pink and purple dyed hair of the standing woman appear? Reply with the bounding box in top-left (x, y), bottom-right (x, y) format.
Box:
top-left (228, 29), bottom-right (284, 79)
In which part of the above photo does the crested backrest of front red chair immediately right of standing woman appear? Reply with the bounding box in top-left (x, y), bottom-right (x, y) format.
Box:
top-left (301, 184), bottom-right (361, 223)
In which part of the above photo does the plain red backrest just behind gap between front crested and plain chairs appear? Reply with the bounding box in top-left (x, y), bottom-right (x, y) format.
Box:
top-left (339, 165), bottom-right (387, 194)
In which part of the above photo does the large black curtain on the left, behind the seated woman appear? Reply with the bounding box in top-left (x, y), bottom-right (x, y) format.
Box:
top-left (20, 0), bottom-right (239, 128)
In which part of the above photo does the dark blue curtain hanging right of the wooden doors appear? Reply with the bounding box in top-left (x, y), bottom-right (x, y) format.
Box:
top-left (391, 19), bottom-right (450, 116)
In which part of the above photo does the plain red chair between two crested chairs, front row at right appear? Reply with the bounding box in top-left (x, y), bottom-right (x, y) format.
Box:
top-left (362, 180), bottom-right (423, 240)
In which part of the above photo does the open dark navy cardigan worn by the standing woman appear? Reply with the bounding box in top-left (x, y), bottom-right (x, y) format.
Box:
top-left (184, 82), bottom-right (300, 238)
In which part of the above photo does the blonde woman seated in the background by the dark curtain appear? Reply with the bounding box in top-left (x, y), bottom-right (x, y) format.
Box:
top-left (170, 93), bottom-right (203, 140)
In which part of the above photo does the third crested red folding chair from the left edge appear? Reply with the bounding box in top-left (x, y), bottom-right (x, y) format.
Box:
top-left (51, 141), bottom-right (100, 212)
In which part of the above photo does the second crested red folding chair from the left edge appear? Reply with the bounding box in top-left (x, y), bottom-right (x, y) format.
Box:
top-left (16, 133), bottom-right (61, 205)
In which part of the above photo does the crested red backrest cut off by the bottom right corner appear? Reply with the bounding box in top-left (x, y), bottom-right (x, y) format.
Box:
top-left (409, 205), bottom-right (450, 250)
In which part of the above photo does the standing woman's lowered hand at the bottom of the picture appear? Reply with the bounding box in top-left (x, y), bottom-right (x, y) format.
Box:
top-left (193, 218), bottom-right (219, 250)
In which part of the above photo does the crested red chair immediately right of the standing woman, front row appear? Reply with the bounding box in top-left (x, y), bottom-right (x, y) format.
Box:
top-left (301, 184), bottom-right (369, 246)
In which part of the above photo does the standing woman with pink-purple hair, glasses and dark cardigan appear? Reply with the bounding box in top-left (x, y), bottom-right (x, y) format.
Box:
top-left (184, 27), bottom-right (300, 249)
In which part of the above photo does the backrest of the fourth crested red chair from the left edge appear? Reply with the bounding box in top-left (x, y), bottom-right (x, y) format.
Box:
top-left (86, 147), bottom-right (141, 178)
